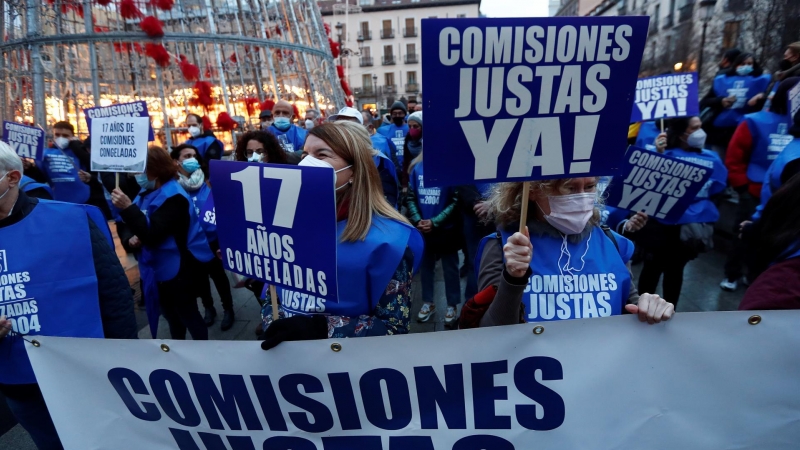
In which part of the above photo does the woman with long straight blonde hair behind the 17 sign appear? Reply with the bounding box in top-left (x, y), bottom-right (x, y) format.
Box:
top-left (261, 122), bottom-right (423, 350)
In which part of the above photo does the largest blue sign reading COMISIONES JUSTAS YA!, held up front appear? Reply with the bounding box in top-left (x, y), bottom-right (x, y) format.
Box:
top-left (422, 16), bottom-right (649, 186)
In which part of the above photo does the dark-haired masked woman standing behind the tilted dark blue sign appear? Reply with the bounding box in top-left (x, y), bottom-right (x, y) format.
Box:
top-left (637, 116), bottom-right (728, 306)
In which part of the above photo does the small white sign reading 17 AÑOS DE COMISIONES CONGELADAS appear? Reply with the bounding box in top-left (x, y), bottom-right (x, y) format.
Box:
top-left (90, 117), bottom-right (150, 173)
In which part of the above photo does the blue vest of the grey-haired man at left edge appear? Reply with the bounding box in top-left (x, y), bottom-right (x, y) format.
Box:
top-left (0, 200), bottom-right (103, 384)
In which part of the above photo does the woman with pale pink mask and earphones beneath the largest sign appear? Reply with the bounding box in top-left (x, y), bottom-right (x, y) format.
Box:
top-left (476, 177), bottom-right (674, 326)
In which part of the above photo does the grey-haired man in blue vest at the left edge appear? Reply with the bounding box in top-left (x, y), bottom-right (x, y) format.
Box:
top-left (0, 142), bottom-right (137, 450)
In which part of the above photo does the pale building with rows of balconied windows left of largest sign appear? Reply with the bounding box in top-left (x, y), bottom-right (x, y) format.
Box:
top-left (319, 0), bottom-right (481, 110)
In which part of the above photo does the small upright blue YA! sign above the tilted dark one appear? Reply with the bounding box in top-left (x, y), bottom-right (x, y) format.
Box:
top-left (631, 72), bottom-right (700, 123)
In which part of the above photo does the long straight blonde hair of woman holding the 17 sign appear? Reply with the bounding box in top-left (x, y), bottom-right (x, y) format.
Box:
top-left (308, 121), bottom-right (408, 242)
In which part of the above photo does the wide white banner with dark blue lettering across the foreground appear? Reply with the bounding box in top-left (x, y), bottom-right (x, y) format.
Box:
top-left (27, 311), bottom-right (800, 450)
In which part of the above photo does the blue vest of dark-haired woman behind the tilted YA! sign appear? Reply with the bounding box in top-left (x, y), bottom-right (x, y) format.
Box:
top-left (664, 148), bottom-right (728, 225)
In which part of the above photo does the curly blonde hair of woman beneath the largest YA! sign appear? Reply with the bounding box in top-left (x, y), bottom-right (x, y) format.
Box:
top-left (487, 178), bottom-right (603, 226)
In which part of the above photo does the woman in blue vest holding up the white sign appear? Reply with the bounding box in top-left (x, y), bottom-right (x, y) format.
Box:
top-left (111, 146), bottom-right (214, 341)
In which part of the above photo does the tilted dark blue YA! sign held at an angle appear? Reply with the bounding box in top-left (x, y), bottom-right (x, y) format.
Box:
top-left (605, 147), bottom-right (712, 224)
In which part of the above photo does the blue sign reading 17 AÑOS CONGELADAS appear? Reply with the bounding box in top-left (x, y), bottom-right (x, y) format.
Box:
top-left (211, 160), bottom-right (338, 304)
